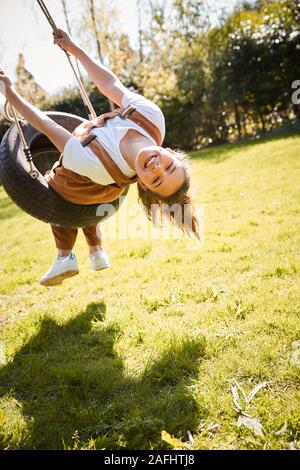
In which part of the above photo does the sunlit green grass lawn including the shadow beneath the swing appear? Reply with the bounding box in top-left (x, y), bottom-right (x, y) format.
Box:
top-left (0, 130), bottom-right (300, 449)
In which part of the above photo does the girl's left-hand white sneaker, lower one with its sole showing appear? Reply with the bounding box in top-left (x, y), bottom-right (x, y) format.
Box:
top-left (40, 253), bottom-right (79, 286)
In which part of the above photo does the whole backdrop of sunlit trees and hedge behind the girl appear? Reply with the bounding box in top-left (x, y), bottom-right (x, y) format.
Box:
top-left (0, 0), bottom-right (300, 150)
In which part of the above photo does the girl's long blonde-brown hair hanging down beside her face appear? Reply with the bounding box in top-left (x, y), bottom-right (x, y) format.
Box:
top-left (137, 151), bottom-right (201, 240)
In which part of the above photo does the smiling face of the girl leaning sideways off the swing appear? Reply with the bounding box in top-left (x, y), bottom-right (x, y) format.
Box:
top-left (135, 145), bottom-right (185, 197)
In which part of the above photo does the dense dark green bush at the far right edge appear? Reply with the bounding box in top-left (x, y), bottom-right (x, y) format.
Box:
top-left (209, 0), bottom-right (300, 140)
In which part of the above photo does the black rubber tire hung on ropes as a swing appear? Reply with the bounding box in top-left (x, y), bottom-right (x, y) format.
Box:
top-left (0, 112), bottom-right (129, 227)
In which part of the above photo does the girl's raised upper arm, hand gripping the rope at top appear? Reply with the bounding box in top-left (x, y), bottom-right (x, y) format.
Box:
top-left (54, 29), bottom-right (127, 106)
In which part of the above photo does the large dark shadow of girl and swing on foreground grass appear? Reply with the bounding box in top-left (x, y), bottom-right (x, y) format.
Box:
top-left (0, 303), bottom-right (204, 449)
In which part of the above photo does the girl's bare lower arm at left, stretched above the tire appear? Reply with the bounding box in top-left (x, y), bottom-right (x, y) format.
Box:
top-left (6, 88), bottom-right (72, 153)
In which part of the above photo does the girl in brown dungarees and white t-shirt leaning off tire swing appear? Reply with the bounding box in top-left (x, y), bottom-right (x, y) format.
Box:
top-left (0, 30), bottom-right (200, 286)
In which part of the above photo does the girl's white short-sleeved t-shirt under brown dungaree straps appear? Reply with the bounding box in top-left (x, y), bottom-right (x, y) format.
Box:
top-left (63, 90), bottom-right (166, 185)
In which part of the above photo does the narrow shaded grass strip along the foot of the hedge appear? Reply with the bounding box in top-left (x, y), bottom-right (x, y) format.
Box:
top-left (190, 125), bottom-right (300, 163)
